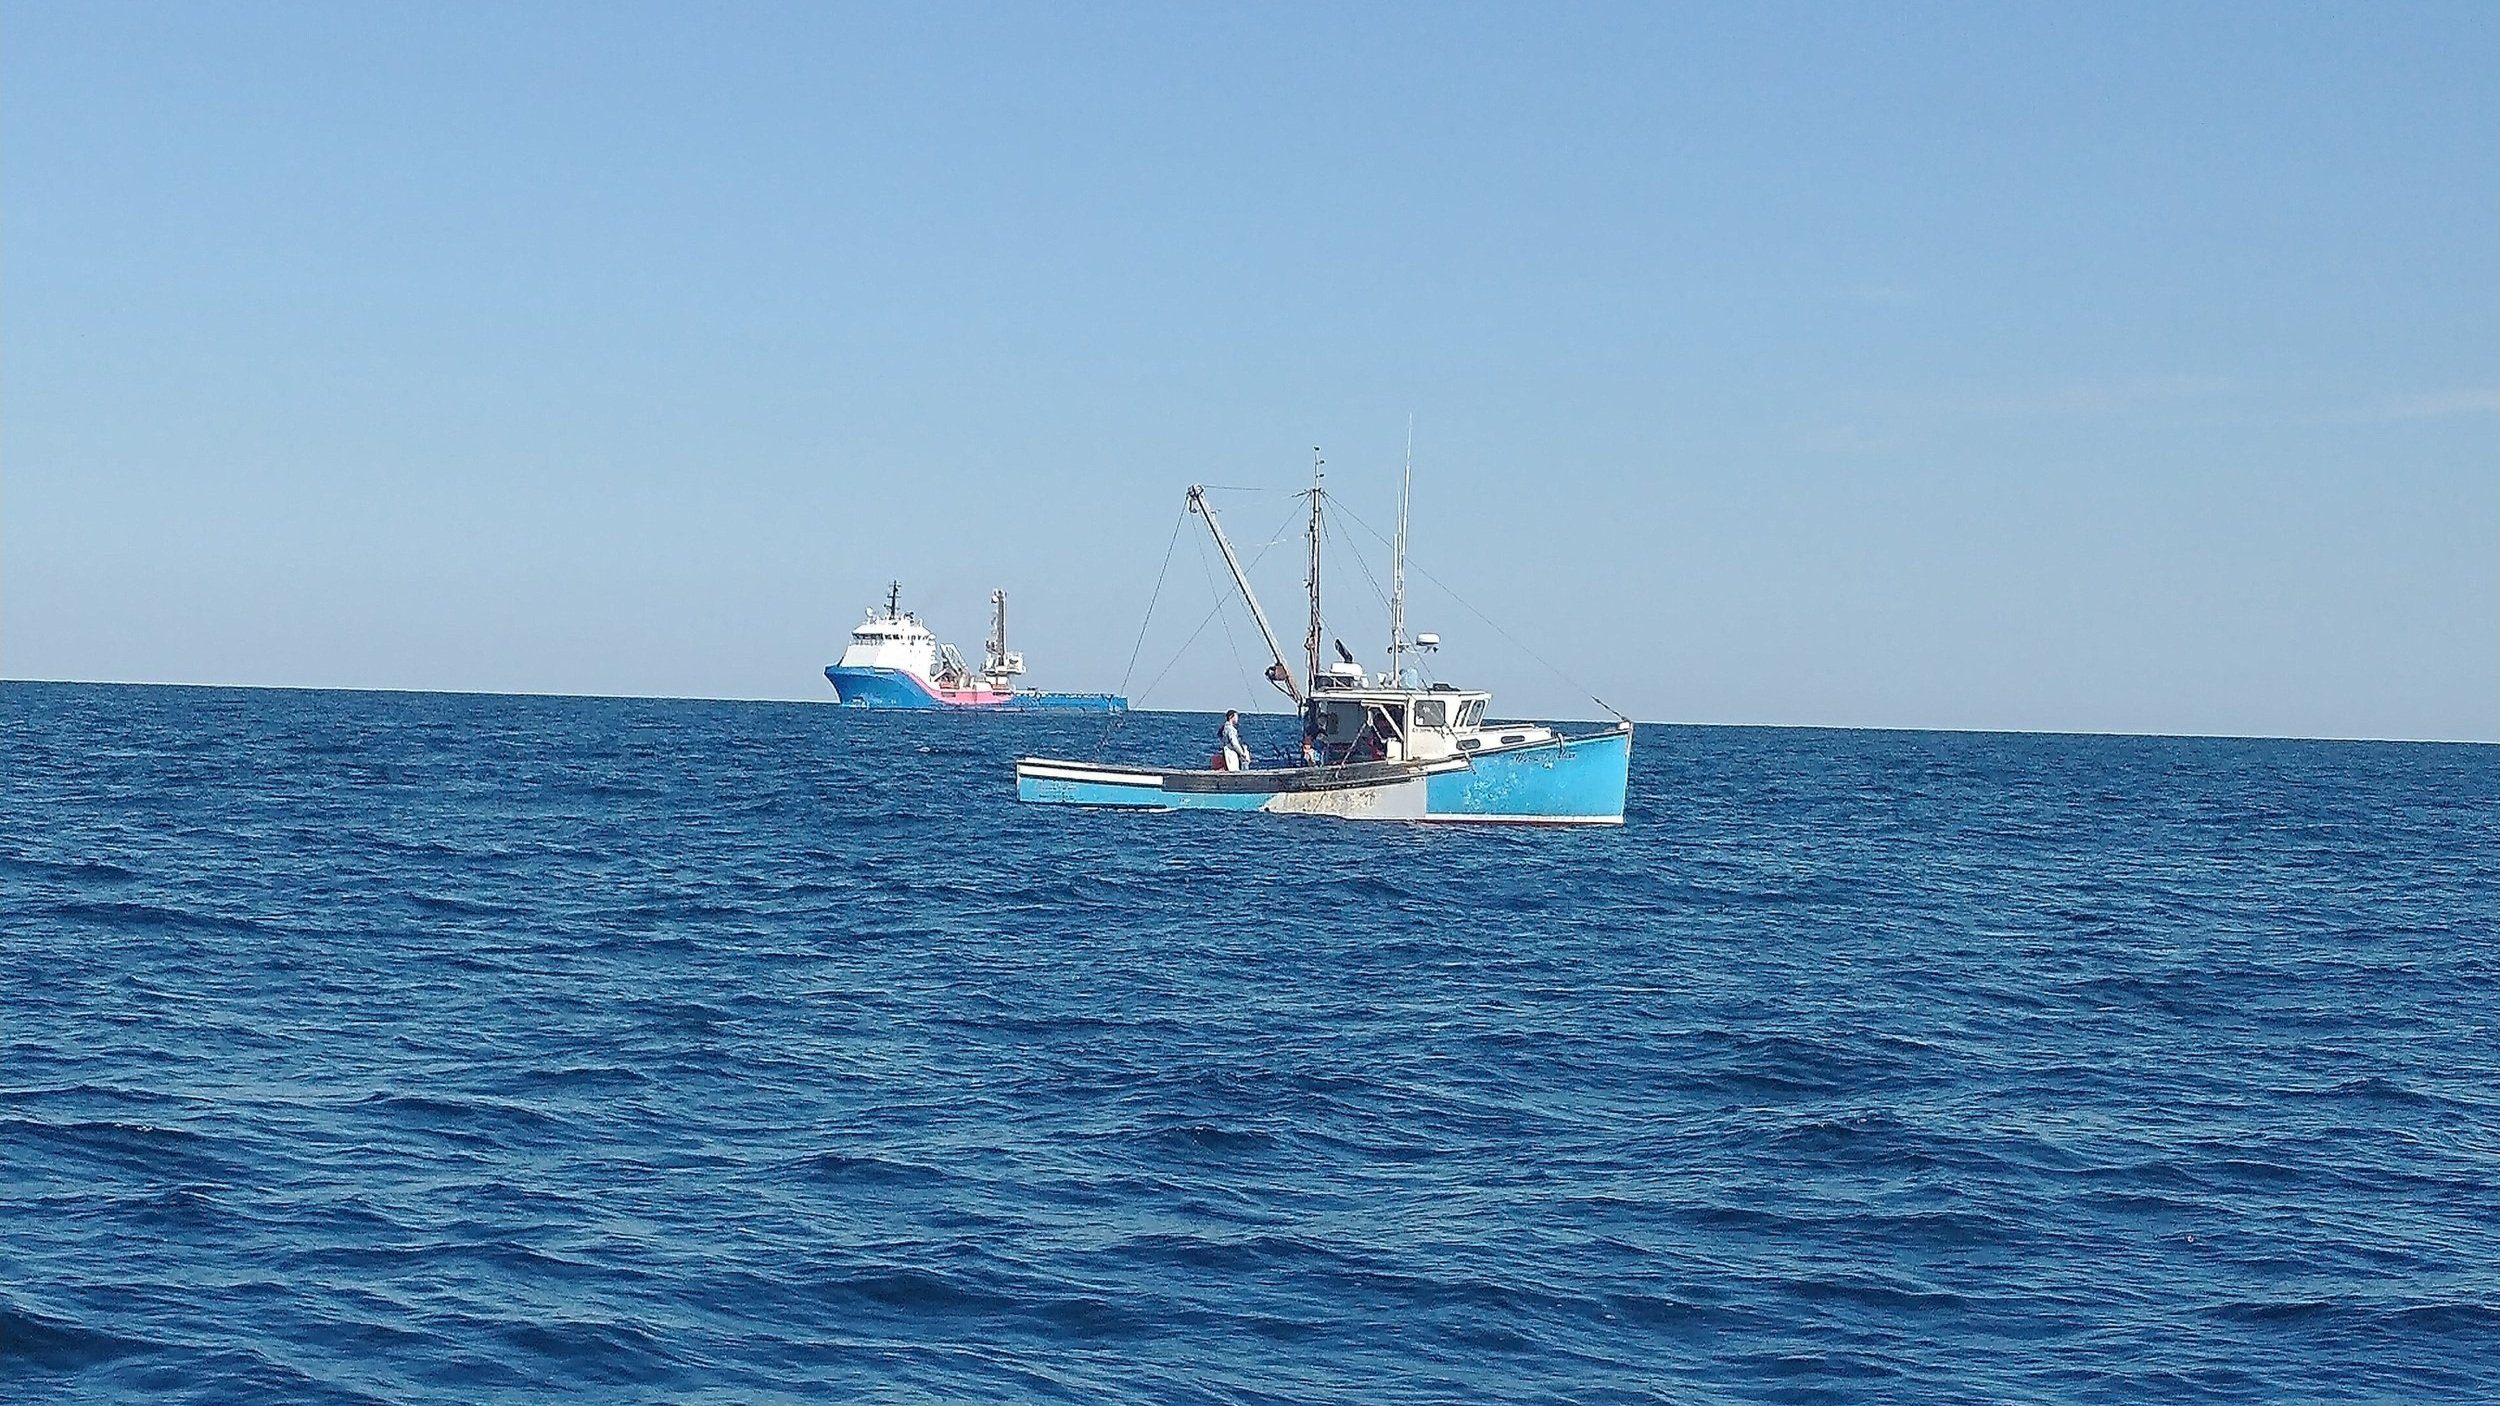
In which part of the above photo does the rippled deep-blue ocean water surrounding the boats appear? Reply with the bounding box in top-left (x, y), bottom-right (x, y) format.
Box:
top-left (0, 685), bottom-right (2500, 1403)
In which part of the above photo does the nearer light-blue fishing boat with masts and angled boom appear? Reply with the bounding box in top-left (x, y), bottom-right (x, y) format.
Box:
top-left (1015, 447), bottom-right (1633, 826)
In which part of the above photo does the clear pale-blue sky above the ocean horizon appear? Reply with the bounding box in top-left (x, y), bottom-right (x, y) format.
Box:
top-left (0, 3), bottom-right (2500, 738)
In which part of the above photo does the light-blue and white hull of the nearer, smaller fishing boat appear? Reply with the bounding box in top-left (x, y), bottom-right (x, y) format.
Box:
top-left (1015, 726), bottom-right (1633, 826)
